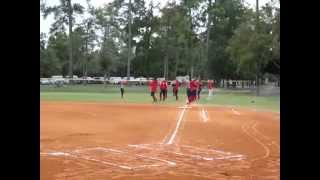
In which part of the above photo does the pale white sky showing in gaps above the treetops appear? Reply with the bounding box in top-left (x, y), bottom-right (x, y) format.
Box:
top-left (40, 0), bottom-right (278, 34)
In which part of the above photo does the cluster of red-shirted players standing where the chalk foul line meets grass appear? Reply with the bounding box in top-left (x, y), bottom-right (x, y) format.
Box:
top-left (149, 78), bottom-right (214, 104)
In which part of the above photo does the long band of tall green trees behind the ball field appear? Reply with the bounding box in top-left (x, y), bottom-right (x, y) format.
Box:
top-left (40, 0), bottom-right (280, 92)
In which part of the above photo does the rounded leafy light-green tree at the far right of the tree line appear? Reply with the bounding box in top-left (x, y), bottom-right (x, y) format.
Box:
top-left (226, 1), bottom-right (280, 80)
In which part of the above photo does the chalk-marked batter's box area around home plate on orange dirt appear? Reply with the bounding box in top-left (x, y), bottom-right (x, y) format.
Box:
top-left (40, 144), bottom-right (245, 170)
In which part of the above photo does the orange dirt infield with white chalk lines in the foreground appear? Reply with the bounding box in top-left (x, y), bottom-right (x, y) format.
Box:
top-left (40, 102), bottom-right (280, 180)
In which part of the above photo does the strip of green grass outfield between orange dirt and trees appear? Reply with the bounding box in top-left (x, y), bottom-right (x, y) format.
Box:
top-left (40, 85), bottom-right (280, 112)
